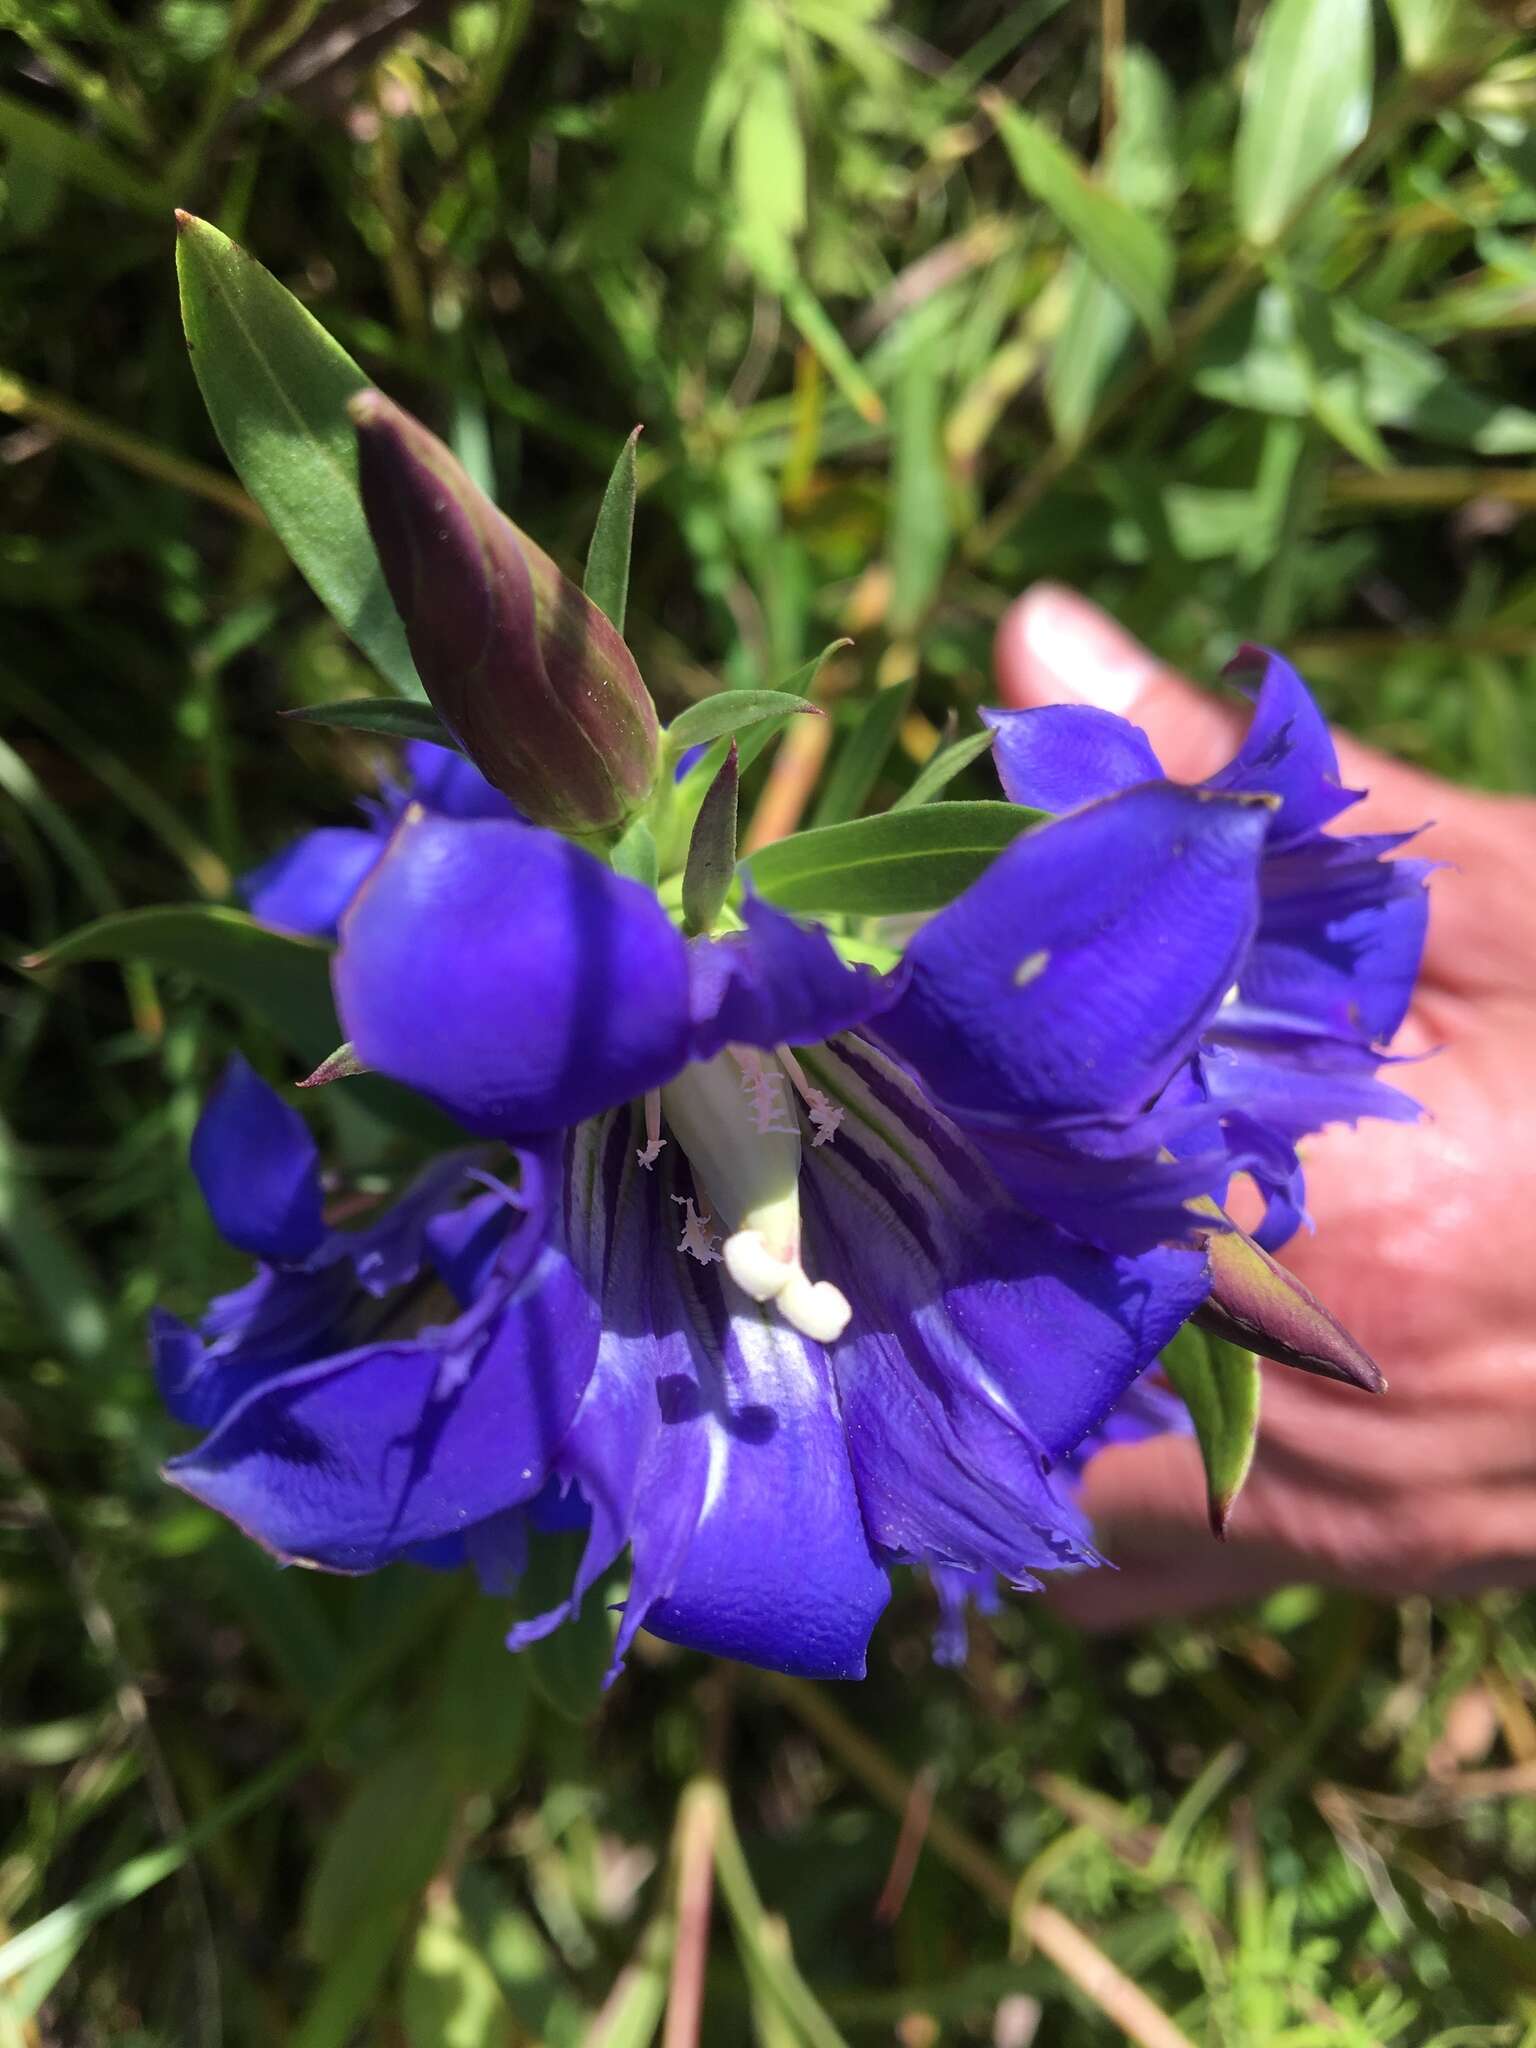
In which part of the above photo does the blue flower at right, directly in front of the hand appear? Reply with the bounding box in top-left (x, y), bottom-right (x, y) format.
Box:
top-left (983, 647), bottom-right (1432, 1249)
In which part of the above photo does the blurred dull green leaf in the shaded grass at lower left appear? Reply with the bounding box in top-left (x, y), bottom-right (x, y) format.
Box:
top-left (303, 1739), bottom-right (457, 1960)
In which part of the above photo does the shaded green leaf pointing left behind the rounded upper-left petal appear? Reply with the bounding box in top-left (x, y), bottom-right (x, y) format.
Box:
top-left (31, 903), bottom-right (340, 1067)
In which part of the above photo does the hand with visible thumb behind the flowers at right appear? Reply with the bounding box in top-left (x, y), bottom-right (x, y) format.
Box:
top-left (995, 584), bottom-right (1536, 1628)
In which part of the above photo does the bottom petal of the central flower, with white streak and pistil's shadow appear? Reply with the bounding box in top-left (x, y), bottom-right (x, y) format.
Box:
top-left (512, 1116), bottom-right (889, 1677)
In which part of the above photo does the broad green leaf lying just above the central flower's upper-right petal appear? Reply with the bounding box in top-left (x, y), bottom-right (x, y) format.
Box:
top-left (743, 803), bottom-right (1042, 918)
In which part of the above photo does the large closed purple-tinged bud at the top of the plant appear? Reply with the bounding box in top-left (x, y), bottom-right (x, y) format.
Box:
top-left (348, 391), bottom-right (659, 840)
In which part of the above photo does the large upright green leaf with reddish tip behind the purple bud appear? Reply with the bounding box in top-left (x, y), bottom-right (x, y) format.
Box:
top-left (176, 213), bottom-right (422, 696)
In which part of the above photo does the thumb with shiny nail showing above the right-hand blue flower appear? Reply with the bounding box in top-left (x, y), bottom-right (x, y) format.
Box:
top-left (995, 584), bottom-right (1247, 782)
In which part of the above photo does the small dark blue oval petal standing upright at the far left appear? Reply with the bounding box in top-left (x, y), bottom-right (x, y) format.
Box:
top-left (193, 1053), bottom-right (326, 1264)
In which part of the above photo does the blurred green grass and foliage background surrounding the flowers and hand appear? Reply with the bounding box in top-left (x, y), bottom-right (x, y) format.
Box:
top-left (0, 0), bottom-right (1536, 2048)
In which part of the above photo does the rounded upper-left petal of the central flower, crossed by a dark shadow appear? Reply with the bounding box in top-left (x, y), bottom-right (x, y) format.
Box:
top-left (334, 809), bottom-right (692, 1137)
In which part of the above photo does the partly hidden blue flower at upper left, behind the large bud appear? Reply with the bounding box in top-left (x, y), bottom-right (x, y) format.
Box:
top-left (240, 739), bottom-right (516, 938)
